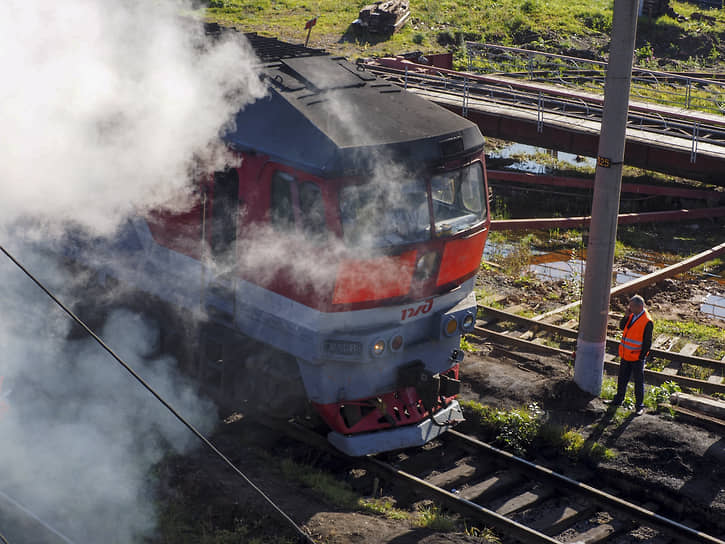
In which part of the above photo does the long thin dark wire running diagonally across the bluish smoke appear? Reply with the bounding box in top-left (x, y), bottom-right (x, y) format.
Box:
top-left (0, 245), bottom-right (315, 544)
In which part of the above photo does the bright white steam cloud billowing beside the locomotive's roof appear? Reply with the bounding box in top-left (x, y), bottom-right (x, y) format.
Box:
top-left (0, 0), bottom-right (264, 231)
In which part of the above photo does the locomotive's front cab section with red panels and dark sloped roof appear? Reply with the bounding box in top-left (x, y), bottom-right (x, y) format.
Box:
top-left (209, 37), bottom-right (490, 455)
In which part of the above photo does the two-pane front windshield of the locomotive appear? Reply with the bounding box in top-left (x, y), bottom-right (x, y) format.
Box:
top-left (340, 162), bottom-right (486, 247)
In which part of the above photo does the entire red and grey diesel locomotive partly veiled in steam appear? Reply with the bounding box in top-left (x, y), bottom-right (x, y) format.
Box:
top-left (67, 35), bottom-right (490, 455)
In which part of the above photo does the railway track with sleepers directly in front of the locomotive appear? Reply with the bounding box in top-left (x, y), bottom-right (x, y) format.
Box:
top-left (277, 423), bottom-right (725, 544)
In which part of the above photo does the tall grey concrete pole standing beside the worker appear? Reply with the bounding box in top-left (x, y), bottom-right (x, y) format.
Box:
top-left (574, 0), bottom-right (639, 395)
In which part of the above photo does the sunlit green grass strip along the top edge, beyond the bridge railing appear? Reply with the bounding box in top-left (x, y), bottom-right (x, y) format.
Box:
top-left (192, 0), bottom-right (725, 73)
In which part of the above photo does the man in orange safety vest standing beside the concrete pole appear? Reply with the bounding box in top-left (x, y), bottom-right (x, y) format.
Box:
top-left (611, 295), bottom-right (654, 416)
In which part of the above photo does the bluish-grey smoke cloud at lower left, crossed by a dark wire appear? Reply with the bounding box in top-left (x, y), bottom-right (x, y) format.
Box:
top-left (0, 254), bottom-right (216, 544)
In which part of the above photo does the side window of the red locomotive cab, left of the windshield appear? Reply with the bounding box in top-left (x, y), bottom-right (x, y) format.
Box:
top-left (269, 170), bottom-right (327, 242)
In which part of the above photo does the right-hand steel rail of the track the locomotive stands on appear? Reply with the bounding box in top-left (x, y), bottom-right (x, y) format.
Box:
top-left (447, 430), bottom-right (725, 544)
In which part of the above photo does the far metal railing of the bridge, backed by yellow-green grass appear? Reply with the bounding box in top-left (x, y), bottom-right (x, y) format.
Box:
top-left (466, 42), bottom-right (725, 115)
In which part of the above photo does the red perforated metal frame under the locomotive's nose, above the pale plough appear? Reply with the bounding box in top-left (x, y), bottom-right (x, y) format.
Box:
top-left (313, 364), bottom-right (458, 434)
